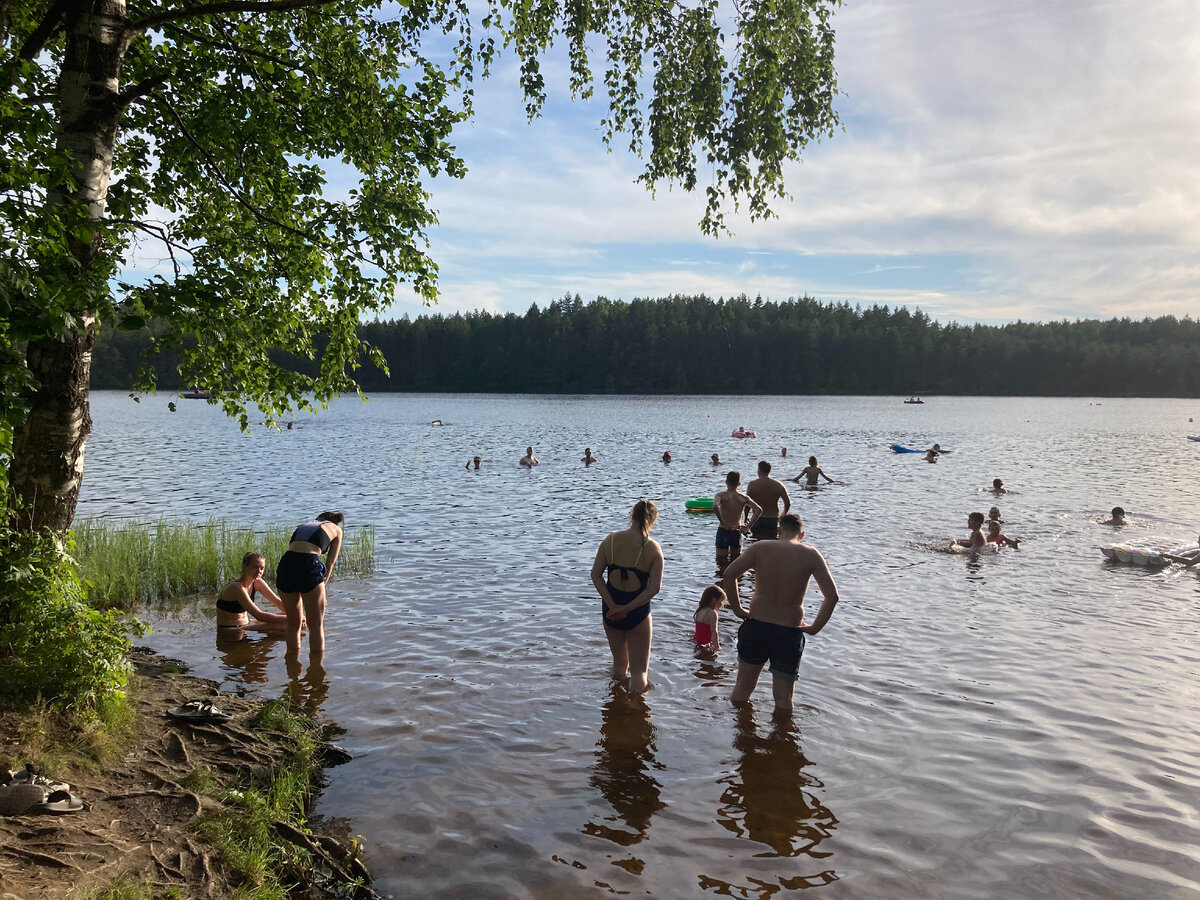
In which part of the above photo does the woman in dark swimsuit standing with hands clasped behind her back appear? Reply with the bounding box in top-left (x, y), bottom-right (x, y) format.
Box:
top-left (592, 500), bottom-right (662, 694)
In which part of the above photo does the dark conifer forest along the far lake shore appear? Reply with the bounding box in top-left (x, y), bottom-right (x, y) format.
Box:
top-left (92, 295), bottom-right (1200, 397)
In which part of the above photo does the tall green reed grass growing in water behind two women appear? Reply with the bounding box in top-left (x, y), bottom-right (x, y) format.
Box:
top-left (74, 518), bottom-right (376, 608)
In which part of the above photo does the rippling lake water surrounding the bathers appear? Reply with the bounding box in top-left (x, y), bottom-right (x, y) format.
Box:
top-left (79, 394), bottom-right (1200, 900)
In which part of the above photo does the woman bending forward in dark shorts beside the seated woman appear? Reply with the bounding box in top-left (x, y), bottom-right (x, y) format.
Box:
top-left (275, 512), bottom-right (346, 654)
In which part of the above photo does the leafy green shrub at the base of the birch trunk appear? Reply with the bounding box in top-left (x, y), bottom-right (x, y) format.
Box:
top-left (0, 532), bottom-right (142, 710)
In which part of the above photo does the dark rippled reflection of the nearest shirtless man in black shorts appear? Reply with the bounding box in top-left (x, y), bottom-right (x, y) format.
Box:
top-left (709, 706), bottom-right (838, 887)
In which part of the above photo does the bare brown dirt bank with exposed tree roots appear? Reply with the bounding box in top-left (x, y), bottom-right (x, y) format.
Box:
top-left (0, 650), bottom-right (369, 900)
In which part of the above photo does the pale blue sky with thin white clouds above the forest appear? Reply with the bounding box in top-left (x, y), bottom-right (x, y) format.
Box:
top-left (384, 0), bottom-right (1200, 323)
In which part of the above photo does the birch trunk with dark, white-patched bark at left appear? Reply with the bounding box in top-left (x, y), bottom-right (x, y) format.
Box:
top-left (10, 0), bottom-right (128, 535)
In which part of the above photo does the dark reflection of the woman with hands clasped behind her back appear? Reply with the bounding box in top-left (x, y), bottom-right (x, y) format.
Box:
top-left (583, 686), bottom-right (666, 847)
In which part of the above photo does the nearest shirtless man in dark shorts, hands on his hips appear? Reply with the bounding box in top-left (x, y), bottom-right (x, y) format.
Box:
top-left (725, 512), bottom-right (838, 712)
